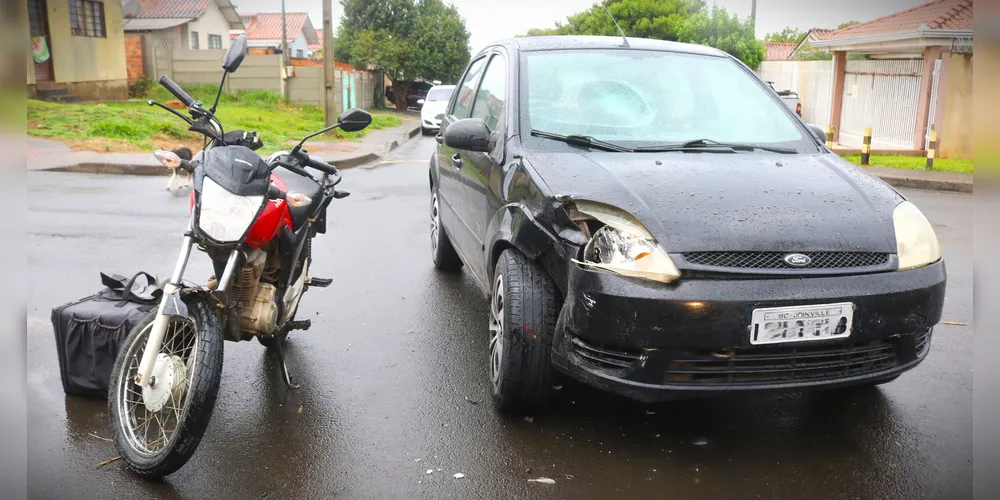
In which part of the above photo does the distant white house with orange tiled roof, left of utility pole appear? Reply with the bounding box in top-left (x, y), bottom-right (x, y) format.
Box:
top-left (233, 12), bottom-right (321, 59)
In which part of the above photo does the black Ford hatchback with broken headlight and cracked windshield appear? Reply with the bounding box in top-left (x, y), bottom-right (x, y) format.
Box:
top-left (429, 37), bottom-right (945, 411)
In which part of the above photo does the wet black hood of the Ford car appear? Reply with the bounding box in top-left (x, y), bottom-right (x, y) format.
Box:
top-left (525, 152), bottom-right (903, 253)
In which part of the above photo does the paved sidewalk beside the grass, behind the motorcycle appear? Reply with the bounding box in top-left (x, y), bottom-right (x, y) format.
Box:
top-left (27, 115), bottom-right (420, 175)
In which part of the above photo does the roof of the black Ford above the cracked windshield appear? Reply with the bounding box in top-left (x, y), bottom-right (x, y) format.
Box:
top-left (483, 35), bottom-right (727, 57)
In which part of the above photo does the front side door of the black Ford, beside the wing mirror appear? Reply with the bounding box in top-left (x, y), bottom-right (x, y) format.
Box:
top-left (458, 52), bottom-right (507, 283)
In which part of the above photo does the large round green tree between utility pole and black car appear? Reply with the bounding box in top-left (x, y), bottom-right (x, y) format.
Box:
top-left (334, 0), bottom-right (470, 109)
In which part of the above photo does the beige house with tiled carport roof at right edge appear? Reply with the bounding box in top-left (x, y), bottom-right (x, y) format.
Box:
top-left (811, 0), bottom-right (973, 156)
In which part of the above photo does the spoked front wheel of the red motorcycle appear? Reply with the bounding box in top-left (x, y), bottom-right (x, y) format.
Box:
top-left (108, 295), bottom-right (223, 478)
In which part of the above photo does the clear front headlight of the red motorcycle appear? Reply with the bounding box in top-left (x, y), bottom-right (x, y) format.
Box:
top-left (198, 177), bottom-right (264, 243)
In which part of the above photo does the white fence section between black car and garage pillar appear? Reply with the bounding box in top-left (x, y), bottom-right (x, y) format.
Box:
top-left (757, 61), bottom-right (833, 129)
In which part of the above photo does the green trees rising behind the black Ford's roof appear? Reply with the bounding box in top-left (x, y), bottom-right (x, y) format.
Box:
top-left (528, 0), bottom-right (764, 68)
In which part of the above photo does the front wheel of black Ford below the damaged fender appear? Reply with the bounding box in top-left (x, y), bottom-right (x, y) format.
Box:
top-left (489, 249), bottom-right (559, 413)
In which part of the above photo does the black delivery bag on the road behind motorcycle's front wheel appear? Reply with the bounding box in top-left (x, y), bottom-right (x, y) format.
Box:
top-left (52, 273), bottom-right (163, 398)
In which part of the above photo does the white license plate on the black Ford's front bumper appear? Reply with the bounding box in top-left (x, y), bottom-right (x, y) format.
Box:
top-left (750, 302), bottom-right (854, 345)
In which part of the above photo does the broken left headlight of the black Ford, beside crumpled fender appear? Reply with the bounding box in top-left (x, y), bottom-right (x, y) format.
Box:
top-left (574, 202), bottom-right (681, 283)
